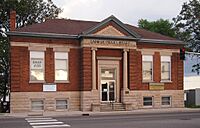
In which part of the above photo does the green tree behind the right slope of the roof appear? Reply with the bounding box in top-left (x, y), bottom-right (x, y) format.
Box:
top-left (138, 19), bottom-right (175, 37)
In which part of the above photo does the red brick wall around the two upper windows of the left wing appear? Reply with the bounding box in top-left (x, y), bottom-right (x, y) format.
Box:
top-left (11, 40), bottom-right (81, 92)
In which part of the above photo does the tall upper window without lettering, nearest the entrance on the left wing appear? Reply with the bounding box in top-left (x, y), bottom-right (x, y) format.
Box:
top-left (55, 52), bottom-right (69, 81)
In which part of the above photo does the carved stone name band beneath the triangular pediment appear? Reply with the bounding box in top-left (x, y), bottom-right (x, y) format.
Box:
top-left (82, 39), bottom-right (136, 49)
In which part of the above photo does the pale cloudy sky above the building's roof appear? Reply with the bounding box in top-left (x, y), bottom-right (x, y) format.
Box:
top-left (54, 0), bottom-right (188, 25)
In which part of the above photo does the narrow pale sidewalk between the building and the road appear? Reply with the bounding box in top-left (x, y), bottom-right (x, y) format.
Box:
top-left (0, 108), bottom-right (200, 118)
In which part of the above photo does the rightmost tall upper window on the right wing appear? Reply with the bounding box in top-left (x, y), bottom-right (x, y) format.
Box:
top-left (161, 56), bottom-right (171, 81)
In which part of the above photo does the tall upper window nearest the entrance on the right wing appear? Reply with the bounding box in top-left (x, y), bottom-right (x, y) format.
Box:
top-left (142, 55), bottom-right (153, 81)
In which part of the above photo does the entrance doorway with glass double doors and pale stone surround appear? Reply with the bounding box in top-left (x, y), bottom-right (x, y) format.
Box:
top-left (98, 57), bottom-right (121, 103)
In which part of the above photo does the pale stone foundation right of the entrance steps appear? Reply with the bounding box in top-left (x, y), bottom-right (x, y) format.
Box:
top-left (123, 90), bottom-right (184, 109)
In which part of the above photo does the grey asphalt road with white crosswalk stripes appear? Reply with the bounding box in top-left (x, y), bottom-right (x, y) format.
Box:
top-left (0, 112), bottom-right (200, 128)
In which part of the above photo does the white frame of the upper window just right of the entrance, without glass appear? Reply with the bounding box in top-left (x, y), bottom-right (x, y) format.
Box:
top-left (142, 55), bottom-right (154, 83)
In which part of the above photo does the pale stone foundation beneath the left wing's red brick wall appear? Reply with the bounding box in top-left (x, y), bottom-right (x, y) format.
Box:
top-left (10, 91), bottom-right (80, 113)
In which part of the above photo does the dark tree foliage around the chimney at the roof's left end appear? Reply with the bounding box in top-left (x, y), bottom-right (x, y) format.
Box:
top-left (0, 0), bottom-right (62, 28)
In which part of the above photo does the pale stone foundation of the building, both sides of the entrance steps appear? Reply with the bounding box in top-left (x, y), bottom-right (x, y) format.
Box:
top-left (10, 90), bottom-right (184, 113)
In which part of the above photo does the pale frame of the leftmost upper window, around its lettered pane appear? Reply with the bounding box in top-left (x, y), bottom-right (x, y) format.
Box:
top-left (29, 50), bottom-right (45, 83)
